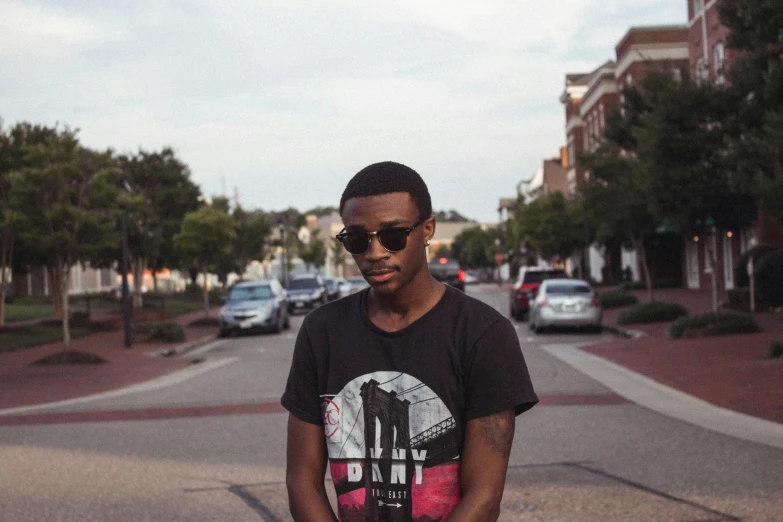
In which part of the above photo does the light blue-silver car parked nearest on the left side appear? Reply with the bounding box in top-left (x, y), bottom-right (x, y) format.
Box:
top-left (219, 279), bottom-right (290, 337)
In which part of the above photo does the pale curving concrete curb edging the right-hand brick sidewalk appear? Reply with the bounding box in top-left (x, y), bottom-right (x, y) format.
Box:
top-left (540, 344), bottom-right (783, 449)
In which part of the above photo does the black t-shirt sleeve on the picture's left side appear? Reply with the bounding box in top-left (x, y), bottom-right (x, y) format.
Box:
top-left (280, 323), bottom-right (323, 426)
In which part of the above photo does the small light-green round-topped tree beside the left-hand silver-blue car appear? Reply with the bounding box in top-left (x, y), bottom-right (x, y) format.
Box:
top-left (174, 206), bottom-right (236, 315)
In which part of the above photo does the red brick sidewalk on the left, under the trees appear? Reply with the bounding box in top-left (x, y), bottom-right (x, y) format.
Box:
top-left (0, 310), bottom-right (217, 410)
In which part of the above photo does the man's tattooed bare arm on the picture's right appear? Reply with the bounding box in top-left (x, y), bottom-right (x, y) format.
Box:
top-left (449, 409), bottom-right (515, 522)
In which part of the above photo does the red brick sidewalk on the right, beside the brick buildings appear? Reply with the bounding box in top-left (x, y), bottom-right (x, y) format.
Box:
top-left (585, 289), bottom-right (783, 423)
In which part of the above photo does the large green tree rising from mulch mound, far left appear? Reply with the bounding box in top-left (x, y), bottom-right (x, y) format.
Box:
top-left (10, 129), bottom-right (119, 346)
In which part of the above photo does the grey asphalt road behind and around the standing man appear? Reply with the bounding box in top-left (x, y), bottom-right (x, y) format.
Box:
top-left (0, 285), bottom-right (783, 521)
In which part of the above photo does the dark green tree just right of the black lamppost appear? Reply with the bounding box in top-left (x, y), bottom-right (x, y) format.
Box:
top-left (119, 147), bottom-right (201, 308)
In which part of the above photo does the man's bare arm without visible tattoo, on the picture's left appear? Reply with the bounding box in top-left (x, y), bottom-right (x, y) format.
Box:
top-left (286, 414), bottom-right (337, 522)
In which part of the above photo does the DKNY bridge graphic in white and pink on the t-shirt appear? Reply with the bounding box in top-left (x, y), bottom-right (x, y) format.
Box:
top-left (321, 372), bottom-right (461, 522)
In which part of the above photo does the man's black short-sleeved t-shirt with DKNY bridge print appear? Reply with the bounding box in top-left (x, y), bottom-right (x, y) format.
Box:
top-left (281, 286), bottom-right (538, 522)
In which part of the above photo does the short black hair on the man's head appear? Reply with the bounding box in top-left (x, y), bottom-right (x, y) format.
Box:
top-left (340, 161), bottom-right (432, 219)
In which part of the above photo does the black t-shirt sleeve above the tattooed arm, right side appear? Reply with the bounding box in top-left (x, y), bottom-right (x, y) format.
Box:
top-left (465, 317), bottom-right (538, 420)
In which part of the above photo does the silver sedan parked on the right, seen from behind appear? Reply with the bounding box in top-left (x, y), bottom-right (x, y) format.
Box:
top-left (530, 279), bottom-right (603, 333)
